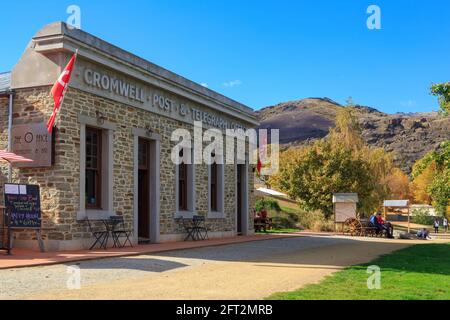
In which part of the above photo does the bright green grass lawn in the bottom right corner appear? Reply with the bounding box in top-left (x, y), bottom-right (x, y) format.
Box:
top-left (268, 244), bottom-right (450, 300)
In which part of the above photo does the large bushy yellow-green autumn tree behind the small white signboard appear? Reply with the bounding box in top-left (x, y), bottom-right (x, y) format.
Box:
top-left (271, 108), bottom-right (392, 217)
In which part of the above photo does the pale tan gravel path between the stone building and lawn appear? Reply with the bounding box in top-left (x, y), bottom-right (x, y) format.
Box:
top-left (0, 237), bottom-right (418, 299)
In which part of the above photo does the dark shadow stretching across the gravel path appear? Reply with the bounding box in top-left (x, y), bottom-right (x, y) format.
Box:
top-left (72, 236), bottom-right (430, 272)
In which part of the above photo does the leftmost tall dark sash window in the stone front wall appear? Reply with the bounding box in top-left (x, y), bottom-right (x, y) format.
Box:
top-left (85, 127), bottom-right (102, 209)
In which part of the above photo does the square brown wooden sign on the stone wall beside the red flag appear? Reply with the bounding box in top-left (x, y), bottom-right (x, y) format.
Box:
top-left (12, 123), bottom-right (53, 168)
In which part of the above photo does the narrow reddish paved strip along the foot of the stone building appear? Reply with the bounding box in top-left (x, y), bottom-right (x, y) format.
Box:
top-left (0, 235), bottom-right (289, 270)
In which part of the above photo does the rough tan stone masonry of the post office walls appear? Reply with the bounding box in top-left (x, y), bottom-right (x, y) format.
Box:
top-left (0, 87), bottom-right (254, 248)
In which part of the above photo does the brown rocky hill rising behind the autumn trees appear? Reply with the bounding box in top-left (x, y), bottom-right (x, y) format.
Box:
top-left (258, 98), bottom-right (450, 173)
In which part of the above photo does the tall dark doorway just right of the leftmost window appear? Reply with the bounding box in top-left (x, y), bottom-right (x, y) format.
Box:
top-left (138, 138), bottom-right (151, 243)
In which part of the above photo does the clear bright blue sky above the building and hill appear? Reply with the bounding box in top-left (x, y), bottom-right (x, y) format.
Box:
top-left (0, 0), bottom-right (450, 113)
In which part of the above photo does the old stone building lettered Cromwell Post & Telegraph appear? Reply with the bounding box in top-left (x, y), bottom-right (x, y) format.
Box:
top-left (0, 23), bottom-right (258, 250)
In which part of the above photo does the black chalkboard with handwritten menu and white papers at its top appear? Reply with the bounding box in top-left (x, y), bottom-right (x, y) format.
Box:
top-left (4, 184), bottom-right (41, 229)
